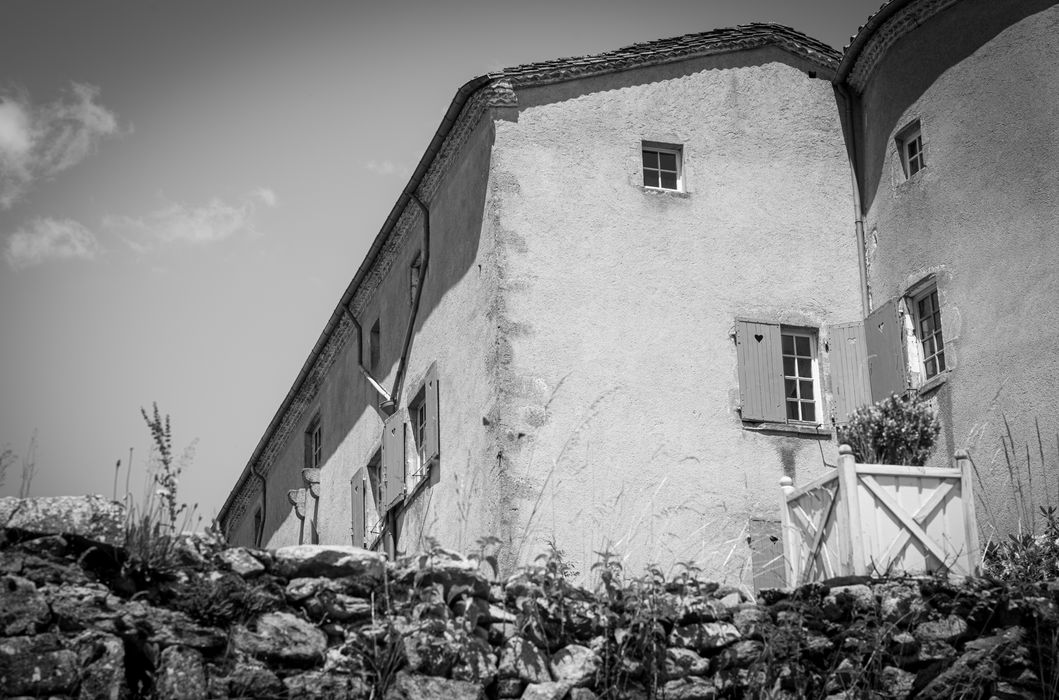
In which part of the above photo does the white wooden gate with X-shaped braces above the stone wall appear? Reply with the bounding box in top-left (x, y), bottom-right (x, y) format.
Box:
top-left (780, 445), bottom-right (979, 587)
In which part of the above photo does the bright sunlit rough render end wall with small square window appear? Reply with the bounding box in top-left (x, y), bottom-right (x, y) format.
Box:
top-left (492, 52), bottom-right (860, 580)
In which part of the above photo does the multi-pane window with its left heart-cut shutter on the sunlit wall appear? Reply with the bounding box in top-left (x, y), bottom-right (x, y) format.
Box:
top-left (735, 320), bottom-right (823, 425)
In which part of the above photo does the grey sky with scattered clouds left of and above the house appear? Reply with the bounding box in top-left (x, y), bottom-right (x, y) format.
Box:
top-left (0, 0), bottom-right (881, 524)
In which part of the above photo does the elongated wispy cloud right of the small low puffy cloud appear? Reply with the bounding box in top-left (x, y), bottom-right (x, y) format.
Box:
top-left (103, 187), bottom-right (276, 252)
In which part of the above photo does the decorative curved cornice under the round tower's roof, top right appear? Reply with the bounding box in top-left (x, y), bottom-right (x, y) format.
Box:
top-left (843, 0), bottom-right (959, 92)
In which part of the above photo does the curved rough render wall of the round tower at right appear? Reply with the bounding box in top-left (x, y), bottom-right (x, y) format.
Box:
top-left (864, 6), bottom-right (1059, 535)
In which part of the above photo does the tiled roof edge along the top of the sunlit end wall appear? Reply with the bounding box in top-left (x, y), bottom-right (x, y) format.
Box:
top-left (489, 22), bottom-right (842, 87)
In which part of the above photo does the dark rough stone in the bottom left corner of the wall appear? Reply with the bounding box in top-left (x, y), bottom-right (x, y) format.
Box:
top-left (0, 634), bottom-right (80, 696)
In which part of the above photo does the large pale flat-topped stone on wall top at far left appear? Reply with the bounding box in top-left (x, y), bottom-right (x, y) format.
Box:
top-left (0, 496), bottom-right (125, 544)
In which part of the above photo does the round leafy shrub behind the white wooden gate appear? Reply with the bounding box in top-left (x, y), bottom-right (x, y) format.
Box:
top-left (839, 394), bottom-right (941, 467)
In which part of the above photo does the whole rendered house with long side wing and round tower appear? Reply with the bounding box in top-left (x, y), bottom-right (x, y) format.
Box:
top-left (219, 0), bottom-right (1059, 586)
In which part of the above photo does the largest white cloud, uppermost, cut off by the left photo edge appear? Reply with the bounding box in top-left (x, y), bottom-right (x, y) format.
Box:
top-left (0, 83), bottom-right (118, 209)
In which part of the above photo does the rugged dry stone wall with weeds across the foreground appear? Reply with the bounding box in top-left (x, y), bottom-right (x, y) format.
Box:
top-left (0, 499), bottom-right (1059, 700)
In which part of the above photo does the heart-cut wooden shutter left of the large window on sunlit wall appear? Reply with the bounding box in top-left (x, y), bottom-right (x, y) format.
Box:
top-left (735, 321), bottom-right (787, 423)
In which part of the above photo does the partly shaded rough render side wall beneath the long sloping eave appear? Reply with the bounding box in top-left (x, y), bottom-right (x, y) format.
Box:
top-left (252, 114), bottom-right (498, 551)
